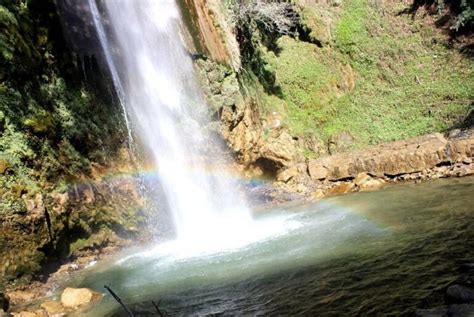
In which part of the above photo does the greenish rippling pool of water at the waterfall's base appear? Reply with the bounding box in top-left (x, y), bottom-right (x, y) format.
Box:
top-left (68, 178), bottom-right (474, 316)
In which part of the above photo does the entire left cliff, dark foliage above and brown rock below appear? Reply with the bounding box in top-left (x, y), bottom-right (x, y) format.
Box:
top-left (0, 0), bottom-right (142, 288)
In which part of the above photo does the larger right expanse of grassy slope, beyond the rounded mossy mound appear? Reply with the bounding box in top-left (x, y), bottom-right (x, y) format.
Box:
top-left (324, 0), bottom-right (474, 146)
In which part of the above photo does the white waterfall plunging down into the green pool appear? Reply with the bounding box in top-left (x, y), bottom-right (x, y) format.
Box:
top-left (88, 0), bottom-right (252, 245)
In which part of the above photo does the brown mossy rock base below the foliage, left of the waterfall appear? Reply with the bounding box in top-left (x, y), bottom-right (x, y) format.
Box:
top-left (0, 160), bottom-right (145, 286)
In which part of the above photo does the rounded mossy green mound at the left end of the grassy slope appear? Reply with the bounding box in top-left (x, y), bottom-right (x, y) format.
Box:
top-left (265, 37), bottom-right (341, 134)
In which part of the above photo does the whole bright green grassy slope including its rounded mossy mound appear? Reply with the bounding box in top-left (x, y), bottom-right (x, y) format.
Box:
top-left (258, 0), bottom-right (474, 152)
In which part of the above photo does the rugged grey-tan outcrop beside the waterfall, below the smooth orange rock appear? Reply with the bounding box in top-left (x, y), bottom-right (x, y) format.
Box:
top-left (197, 60), bottom-right (298, 176)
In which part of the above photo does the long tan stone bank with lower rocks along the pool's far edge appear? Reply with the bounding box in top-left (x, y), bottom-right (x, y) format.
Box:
top-left (277, 129), bottom-right (474, 199)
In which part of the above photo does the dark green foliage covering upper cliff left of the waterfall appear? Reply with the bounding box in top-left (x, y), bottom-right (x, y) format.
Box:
top-left (0, 0), bottom-right (123, 214)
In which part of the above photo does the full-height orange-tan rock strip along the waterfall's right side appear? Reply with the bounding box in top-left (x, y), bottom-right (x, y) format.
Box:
top-left (182, 0), bottom-right (304, 176)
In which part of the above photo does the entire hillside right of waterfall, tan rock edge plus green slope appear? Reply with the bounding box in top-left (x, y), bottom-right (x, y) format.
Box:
top-left (183, 0), bottom-right (472, 176)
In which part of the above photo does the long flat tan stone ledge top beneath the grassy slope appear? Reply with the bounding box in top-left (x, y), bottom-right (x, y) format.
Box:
top-left (308, 133), bottom-right (474, 181)
